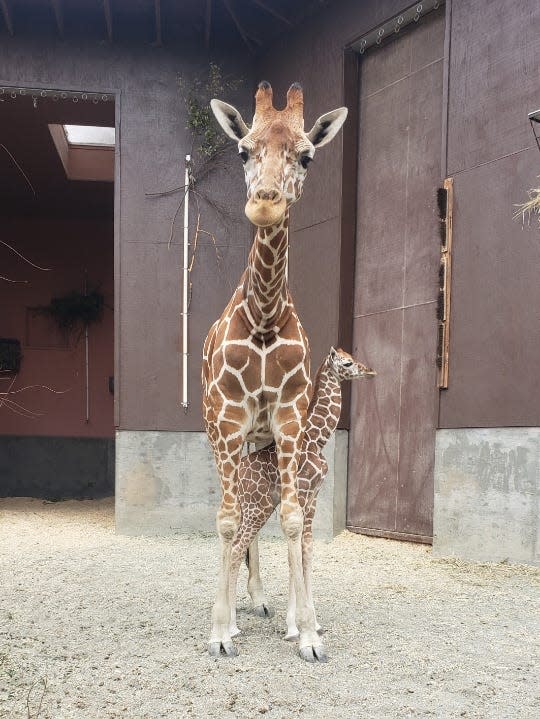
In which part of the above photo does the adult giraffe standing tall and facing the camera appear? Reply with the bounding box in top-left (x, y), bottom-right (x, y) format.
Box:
top-left (202, 82), bottom-right (347, 661)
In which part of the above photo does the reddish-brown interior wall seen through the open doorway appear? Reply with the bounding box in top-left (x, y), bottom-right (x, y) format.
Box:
top-left (0, 218), bottom-right (114, 438)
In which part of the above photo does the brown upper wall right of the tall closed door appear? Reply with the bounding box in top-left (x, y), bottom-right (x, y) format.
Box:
top-left (439, 0), bottom-right (540, 428)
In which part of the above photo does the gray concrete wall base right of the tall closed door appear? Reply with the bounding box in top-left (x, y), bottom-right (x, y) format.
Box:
top-left (433, 427), bottom-right (540, 565)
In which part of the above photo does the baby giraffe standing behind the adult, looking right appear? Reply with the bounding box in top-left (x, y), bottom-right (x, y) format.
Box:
top-left (230, 347), bottom-right (376, 662)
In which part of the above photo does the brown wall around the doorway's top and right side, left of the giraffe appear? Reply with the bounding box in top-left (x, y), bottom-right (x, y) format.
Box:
top-left (0, 34), bottom-right (252, 430)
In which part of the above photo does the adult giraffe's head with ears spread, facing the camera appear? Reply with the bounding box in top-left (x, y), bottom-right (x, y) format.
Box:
top-left (210, 82), bottom-right (347, 227)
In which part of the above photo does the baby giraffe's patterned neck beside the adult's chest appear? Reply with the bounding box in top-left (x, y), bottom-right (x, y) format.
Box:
top-left (305, 358), bottom-right (341, 449)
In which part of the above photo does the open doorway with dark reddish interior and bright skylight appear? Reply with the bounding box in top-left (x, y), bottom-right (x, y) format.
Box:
top-left (0, 87), bottom-right (118, 500)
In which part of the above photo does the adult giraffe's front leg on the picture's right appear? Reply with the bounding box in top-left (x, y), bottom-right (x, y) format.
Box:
top-left (277, 433), bottom-right (327, 662)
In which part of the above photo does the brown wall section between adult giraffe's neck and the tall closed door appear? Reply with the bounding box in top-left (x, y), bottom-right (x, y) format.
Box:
top-left (258, 0), bottom-right (403, 388)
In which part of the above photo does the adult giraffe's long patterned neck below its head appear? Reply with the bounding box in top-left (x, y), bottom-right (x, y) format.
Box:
top-left (243, 212), bottom-right (292, 339)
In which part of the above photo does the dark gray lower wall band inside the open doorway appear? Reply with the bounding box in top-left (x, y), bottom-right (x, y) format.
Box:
top-left (0, 435), bottom-right (114, 500)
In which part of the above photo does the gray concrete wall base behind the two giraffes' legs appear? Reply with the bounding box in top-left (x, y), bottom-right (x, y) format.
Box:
top-left (116, 430), bottom-right (348, 540)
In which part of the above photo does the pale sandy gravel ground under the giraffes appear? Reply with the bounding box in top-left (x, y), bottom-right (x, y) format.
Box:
top-left (0, 499), bottom-right (540, 719)
